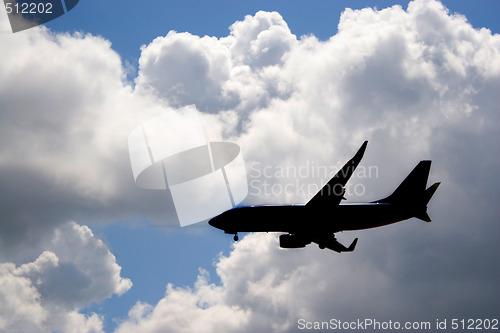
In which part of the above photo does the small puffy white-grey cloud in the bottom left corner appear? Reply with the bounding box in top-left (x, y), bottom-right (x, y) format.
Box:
top-left (0, 222), bottom-right (132, 332)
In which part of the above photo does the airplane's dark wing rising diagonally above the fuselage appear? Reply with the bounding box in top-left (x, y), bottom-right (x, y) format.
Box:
top-left (306, 141), bottom-right (368, 208)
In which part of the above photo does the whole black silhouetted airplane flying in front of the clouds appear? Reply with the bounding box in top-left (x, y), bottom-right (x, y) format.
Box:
top-left (208, 141), bottom-right (440, 252)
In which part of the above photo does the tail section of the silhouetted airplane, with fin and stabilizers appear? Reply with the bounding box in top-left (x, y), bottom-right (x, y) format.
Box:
top-left (375, 161), bottom-right (441, 222)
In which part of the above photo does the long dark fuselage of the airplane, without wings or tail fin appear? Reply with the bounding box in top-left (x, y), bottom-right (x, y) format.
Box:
top-left (209, 203), bottom-right (414, 234)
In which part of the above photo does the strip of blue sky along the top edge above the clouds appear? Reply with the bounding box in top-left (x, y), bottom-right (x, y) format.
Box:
top-left (47, 0), bottom-right (500, 80)
